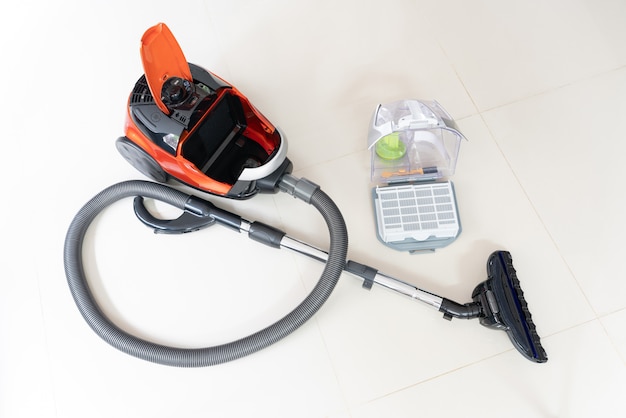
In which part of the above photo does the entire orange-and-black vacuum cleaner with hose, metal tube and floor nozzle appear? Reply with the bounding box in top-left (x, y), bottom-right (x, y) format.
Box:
top-left (64, 23), bottom-right (547, 367)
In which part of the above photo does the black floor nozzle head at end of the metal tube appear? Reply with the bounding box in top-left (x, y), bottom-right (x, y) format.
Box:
top-left (472, 251), bottom-right (548, 363)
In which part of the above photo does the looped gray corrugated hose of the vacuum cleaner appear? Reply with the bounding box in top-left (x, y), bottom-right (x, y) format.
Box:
top-left (63, 180), bottom-right (348, 367)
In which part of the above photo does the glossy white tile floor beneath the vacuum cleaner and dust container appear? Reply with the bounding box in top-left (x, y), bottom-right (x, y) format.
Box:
top-left (0, 0), bottom-right (626, 418)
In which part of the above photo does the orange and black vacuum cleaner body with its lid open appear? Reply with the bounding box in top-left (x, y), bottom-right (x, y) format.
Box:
top-left (116, 23), bottom-right (291, 199)
